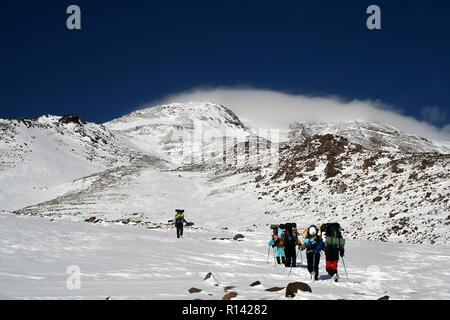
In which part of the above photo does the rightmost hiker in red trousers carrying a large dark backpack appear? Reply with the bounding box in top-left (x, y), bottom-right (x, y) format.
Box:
top-left (320, 223), bottom-right (345, 282)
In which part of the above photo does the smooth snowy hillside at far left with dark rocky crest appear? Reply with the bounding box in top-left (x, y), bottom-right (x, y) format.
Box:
top-left (0, 115), bottom-right (147, 209)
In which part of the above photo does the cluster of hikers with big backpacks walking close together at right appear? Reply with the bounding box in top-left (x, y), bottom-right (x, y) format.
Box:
top-left (269, 223), bottom-right (345, 282)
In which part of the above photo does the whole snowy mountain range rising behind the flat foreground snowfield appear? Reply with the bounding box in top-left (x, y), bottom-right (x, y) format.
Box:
top-left (0, 102), bottom-right (450, 243)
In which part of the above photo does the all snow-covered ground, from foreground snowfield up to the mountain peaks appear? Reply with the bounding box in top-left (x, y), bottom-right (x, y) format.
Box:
top-left (0, 102), bottom-right (450, 299)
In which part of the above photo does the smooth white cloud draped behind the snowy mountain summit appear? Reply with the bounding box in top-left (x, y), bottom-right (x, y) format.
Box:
top-left (144, 88), bottom-right (450, 141)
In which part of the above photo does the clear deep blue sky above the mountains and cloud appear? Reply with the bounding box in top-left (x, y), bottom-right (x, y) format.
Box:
top-left (0, 0), bottom-right (450, 128)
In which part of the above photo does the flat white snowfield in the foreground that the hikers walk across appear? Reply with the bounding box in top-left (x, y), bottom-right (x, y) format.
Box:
top-left (0, 214), bottom-right (450, 300)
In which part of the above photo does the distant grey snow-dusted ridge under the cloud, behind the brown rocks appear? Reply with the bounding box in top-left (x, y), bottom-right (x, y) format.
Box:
top-left (289, 120), bottom-right (450, 154)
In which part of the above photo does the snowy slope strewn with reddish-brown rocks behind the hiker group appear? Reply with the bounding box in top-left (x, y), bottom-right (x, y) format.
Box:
top-left (248, 134), bottom-right (450, 243)
